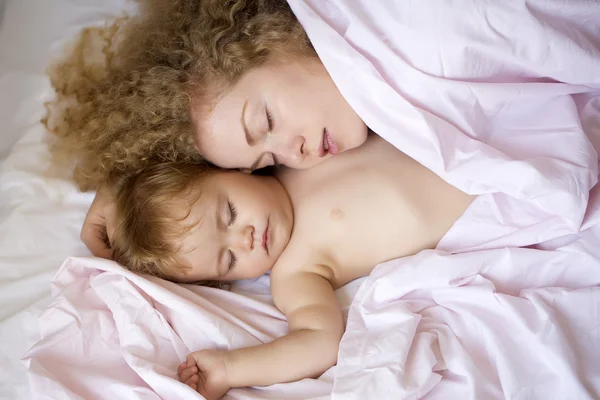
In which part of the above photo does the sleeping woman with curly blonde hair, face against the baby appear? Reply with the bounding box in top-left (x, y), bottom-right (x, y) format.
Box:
top-left (47, 0), bottom-right (368, 256)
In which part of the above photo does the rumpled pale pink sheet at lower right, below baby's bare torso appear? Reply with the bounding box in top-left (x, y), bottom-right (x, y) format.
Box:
top-left (332, 188), bottom-right (600, 400)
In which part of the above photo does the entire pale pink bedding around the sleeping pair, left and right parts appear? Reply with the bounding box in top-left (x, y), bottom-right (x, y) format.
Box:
top-left (25, 0), bottom-right (600, 399)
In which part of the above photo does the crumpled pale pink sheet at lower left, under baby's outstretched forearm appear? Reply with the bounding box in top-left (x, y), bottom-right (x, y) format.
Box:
top-left (25, 257), bottom-right (356, 400)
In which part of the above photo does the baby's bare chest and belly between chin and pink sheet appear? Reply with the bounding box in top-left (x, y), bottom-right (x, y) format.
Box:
top-left (280, 136), bottom-right (469, 284)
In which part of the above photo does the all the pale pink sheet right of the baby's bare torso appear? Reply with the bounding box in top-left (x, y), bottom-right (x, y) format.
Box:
top-left (289, 0), bottom-right (600, 400)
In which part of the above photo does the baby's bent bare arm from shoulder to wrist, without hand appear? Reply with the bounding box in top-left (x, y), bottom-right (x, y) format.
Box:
top-left (227, 271), bottom-right (344, 387)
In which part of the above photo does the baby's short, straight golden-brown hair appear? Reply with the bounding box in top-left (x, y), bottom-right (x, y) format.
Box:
top-left (111, 163), bottom-right (212, 284)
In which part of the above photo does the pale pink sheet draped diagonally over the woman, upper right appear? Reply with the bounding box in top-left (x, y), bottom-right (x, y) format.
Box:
top-left (288, 0), bottom-right (600, 251)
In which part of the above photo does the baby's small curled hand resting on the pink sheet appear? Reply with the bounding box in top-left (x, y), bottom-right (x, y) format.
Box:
top-left (177, 350), bottom-right (231, 400)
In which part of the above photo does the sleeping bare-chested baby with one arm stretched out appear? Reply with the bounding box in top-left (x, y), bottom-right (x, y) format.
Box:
top-left (112, 135), bottom-right (473, 399)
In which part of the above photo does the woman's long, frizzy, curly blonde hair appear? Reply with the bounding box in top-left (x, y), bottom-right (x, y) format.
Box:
top-left (42, 0), bottom-right (316, 190)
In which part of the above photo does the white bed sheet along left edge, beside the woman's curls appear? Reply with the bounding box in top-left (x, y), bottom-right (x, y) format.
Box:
top-left (0, 0), bottom-right (131, 400)
